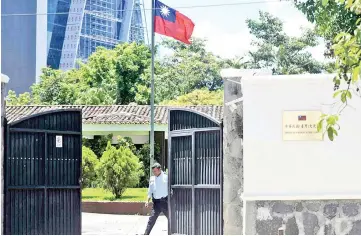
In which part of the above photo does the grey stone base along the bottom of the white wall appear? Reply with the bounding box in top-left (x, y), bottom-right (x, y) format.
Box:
top-left (247, 200), bottom-right (361, 235)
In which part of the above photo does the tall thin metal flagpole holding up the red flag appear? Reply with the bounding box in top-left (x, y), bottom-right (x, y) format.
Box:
top-left (149, 0), bottom-right (155, 176)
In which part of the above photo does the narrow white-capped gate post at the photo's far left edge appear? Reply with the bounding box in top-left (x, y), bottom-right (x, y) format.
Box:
top-left (0, 74), bottom-right (9, 234)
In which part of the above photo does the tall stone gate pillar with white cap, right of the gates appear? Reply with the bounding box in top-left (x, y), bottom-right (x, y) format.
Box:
top-left (221, 69), bottom-right (272, 235)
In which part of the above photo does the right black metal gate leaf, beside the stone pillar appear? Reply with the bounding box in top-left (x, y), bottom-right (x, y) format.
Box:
top-left (168, 109), bottom-right (223, 235)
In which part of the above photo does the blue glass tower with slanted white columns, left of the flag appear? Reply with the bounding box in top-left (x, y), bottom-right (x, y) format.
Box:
top-left (47, 0), bottom-right (145, 70)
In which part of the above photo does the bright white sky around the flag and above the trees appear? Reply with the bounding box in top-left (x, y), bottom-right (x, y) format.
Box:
top-left (144, 0), bottom-right (324, 60)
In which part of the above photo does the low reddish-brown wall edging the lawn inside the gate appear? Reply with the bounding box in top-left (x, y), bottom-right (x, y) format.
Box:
top-left (82, 202), bottom-right (152, 215)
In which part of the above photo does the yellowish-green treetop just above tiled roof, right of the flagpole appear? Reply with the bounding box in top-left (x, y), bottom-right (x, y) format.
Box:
top-left (161, 88), bottom-right (223, 106)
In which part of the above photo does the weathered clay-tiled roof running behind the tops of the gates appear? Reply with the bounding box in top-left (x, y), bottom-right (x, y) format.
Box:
top-left (6, 105), bottom-right (223, 124)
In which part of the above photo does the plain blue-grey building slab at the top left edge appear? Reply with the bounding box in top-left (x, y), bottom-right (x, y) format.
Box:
top-left (1, 0), bottom-right (47, 93)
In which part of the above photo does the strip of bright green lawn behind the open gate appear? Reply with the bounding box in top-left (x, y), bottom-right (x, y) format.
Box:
top-left (82, 188), bottom-right (147, 202)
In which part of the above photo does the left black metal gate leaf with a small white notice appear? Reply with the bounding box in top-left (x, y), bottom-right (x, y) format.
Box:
top-left (4, 109), bottom-right (82, 235)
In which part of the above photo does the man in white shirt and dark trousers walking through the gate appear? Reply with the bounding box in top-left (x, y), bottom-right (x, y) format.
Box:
top-left (144, 163), bottom-right (168, 235)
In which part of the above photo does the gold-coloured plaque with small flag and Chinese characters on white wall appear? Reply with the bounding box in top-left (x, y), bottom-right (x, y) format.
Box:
top-left (282, 111), bottom-right (323, 141)
